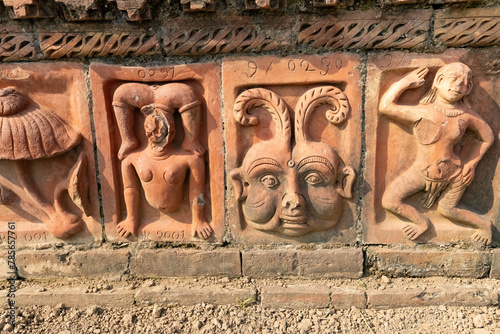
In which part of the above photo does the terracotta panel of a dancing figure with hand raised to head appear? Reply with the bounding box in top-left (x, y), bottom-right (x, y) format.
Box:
top-left (363, 50), bottom-right (500, 244)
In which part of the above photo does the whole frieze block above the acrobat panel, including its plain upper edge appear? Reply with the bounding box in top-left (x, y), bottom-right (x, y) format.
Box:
top-left (163, 17), bottom-right (290, 55)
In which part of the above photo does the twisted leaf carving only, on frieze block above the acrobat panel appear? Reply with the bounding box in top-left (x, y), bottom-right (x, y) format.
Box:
top-left (163, 24), bottom-right (287, 55)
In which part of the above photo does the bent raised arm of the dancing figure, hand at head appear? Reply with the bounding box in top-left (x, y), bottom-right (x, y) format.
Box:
top-left (379, 67), bottom-right (429, 122)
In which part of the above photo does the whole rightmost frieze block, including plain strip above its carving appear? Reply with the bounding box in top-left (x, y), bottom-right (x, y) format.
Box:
top-left (434, 8), bottom-right (500, 47)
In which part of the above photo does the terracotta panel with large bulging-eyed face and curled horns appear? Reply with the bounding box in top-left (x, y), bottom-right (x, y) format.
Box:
top-left (223, 54), bottom-right (361, 243)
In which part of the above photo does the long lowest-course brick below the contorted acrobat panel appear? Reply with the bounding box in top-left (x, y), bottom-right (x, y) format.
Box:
top-left (135, 286), bottom-right (257, 305)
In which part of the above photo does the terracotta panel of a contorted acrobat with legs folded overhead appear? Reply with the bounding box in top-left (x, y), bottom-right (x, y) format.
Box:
top-left (90, 64), bottom-right (224, 242)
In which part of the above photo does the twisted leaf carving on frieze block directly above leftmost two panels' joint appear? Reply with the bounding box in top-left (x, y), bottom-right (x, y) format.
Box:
top-left (40, 32), bottom-right (159, 59)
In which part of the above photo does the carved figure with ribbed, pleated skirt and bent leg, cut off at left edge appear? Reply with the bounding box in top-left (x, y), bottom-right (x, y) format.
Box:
top-left (0, 87), bottom-right (89, 239)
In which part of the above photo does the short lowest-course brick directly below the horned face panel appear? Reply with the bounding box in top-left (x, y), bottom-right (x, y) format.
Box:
top-left (261, 285), bottom-right (330, 308)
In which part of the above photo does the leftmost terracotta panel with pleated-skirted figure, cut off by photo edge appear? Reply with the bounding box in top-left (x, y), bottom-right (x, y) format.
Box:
top-left (0, 64), bottom-right (101, 244)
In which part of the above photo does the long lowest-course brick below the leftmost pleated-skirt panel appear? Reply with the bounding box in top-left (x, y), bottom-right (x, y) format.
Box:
top-left (16, 286), bottom-right (134, 308)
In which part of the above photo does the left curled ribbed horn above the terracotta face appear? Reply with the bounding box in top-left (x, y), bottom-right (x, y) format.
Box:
top-left (233, 88), bottom-right (291, 143)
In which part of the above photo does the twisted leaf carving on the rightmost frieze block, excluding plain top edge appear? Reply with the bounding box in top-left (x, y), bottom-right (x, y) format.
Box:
top-left (434, 16), bottom-right (500, 47)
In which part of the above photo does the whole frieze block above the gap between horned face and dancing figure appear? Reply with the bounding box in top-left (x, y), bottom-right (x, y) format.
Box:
top-left (298, 11), bottom-right (431, 49)
